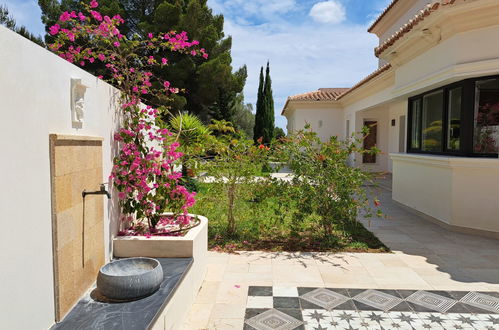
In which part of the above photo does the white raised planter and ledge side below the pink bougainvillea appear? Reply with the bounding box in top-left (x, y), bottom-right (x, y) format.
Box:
top-left (113, 214), bottom-right (208, 330)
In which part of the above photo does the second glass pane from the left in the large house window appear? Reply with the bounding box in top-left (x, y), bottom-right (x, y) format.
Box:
top-left (421, 90), bottom-right (444, 152)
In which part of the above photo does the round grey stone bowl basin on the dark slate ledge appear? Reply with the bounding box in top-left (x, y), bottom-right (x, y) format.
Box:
top-left (97, 258), bottom-right (163, 301)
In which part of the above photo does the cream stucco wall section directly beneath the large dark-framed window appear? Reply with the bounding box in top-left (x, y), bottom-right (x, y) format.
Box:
top-left (392, 154), bottom-right (499, 233)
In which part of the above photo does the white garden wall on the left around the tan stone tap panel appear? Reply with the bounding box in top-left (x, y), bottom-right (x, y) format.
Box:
top-left (0, 26), bottom-right (121, 330)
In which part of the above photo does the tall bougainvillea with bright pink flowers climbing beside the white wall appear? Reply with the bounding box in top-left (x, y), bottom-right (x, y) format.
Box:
top-left (49, 0), bottom-right (208, 235)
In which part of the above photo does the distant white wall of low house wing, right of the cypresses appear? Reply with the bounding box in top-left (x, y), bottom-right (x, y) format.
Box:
top-left (287, 107), bottom-right (345, 141)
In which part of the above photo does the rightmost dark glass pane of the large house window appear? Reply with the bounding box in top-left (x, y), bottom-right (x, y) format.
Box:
top-left (473, 79), bottom-right (499, 154)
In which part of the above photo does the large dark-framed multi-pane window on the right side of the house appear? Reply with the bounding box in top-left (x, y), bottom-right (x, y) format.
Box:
top-left (407, 77), bottom-right (499, 157)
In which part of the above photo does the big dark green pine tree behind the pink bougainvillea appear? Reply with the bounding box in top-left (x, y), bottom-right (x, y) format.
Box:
top-left (38, 0), bottom-right (247, 122)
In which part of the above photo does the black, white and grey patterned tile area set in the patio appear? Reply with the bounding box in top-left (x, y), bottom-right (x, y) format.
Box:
top-left (244, 286), bottom-right (499, 330)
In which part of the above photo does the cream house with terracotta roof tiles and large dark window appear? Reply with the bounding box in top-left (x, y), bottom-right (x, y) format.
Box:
top-left (283, 0), bottom-right (499, 237)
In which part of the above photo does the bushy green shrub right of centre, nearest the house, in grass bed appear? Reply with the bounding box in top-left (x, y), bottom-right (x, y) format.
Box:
top-left (279, 128), bottom-right (381, 239)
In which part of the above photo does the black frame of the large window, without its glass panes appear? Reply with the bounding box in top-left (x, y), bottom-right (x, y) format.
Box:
top-left (406, 75), bottom-right (499, 158)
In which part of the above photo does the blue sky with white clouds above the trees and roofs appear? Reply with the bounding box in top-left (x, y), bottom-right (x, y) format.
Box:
top-left (0, 0), bottom-right (390, 128)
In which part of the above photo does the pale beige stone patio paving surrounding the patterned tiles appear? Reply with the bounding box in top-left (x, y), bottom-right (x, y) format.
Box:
top-left (185, 185), bottom-right (499, 330)
